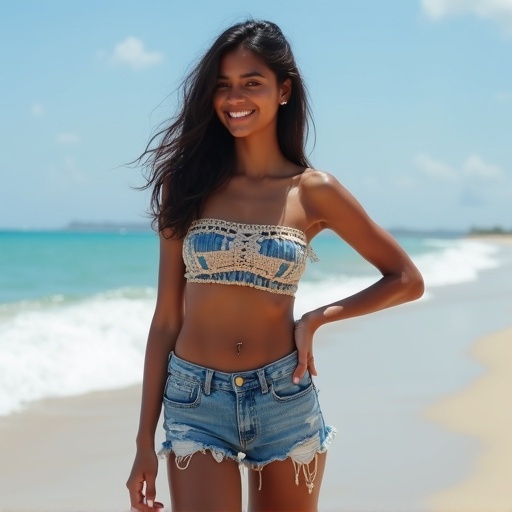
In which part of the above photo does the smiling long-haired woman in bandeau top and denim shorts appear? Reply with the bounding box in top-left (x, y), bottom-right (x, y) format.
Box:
top-left (127, 21), bottom-right (423, 512)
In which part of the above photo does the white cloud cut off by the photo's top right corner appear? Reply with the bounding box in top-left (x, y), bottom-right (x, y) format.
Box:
top-left (421, 0), bottom-right (512, 34)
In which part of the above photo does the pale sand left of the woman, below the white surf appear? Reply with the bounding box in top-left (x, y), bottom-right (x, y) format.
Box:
top-left (0, 387), bottom-right (169, 512)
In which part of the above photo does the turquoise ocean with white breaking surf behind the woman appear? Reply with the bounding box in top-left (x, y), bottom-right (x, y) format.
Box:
top-left (0, 230), bottom-right (501, 416)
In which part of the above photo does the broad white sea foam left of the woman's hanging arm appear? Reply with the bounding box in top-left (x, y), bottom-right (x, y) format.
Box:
top-left (0, 289), bottom-right (155, 415)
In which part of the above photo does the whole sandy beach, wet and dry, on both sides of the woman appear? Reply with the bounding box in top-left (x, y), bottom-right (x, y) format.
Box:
top-left (0, 238), bottom-right (512, 512)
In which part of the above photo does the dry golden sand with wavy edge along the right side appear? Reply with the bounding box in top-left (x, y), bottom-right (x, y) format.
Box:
top-left (425, 327), bottom-right (512, 512)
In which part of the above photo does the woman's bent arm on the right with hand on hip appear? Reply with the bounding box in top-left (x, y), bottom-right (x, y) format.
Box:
top-left (293, 171), bottom-right (424, 379)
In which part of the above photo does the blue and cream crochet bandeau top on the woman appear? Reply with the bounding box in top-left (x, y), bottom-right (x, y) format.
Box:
top-left (183, 219), bottom-right (317, 296)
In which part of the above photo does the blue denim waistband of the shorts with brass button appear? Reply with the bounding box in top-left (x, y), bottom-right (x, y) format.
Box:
top-left (168, 351), bottom-right (298, 395)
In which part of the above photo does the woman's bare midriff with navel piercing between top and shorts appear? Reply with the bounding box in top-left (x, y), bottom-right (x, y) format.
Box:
top-left (174, 283), bottom-right (295, 373)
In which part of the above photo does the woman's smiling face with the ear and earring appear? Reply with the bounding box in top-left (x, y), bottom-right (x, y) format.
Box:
top-left (213, 47), bottom-right (291, 137)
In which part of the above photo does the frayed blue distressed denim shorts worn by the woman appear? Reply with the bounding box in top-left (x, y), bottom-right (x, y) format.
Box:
top-left (159, 352), bottom-right (336, 492)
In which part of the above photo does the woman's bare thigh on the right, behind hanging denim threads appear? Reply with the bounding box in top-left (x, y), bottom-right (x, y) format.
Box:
top-left (249, 453), bottom-right (327, 512)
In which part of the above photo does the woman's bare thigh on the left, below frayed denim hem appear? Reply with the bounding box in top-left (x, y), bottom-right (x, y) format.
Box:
top-left (167, 451), bottom-right (242, 512)
